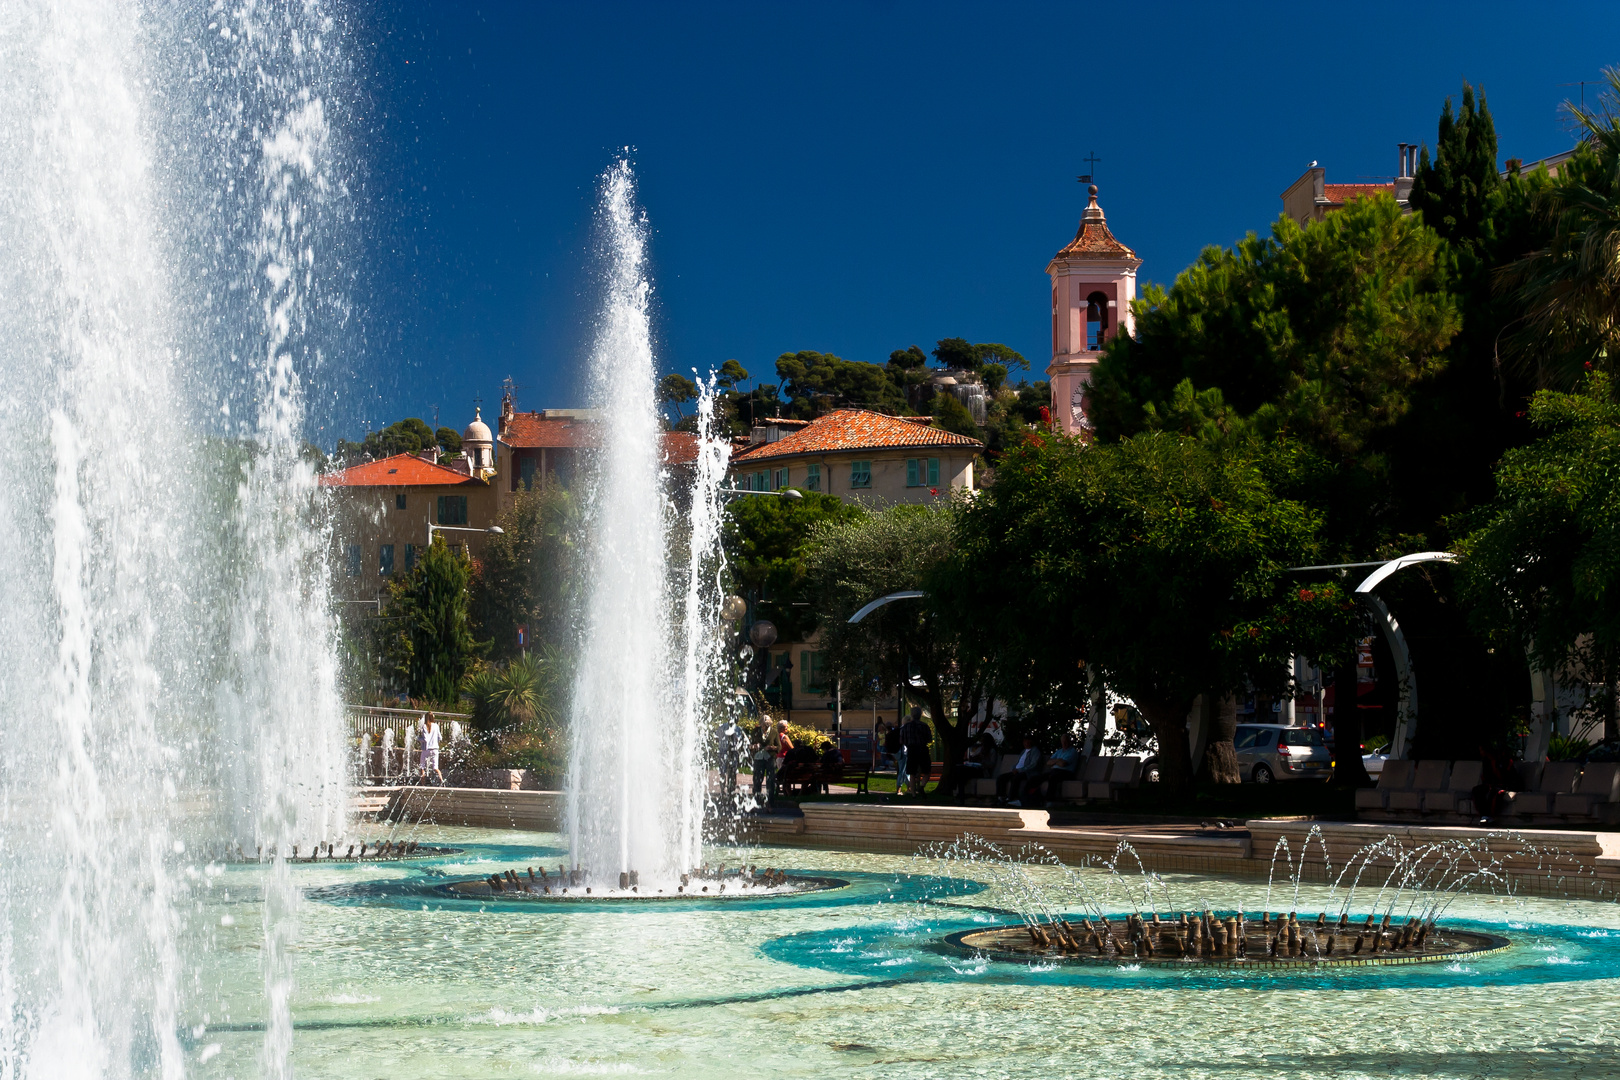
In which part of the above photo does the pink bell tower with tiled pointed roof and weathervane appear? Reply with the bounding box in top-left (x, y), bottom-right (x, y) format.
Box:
top-left (1047, 185), bottom-right (1142, 436)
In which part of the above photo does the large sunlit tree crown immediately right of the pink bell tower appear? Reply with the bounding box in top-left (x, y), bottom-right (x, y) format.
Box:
top-left (1094, 196), bottom-right (1458, 460)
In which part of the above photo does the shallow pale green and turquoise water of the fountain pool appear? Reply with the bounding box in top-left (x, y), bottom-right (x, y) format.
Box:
top-left (188, 829), bottom-right (1620, 1080)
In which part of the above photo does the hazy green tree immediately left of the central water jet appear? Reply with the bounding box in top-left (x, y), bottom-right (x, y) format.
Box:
top-left (470, 484), bottom-right (583, 659)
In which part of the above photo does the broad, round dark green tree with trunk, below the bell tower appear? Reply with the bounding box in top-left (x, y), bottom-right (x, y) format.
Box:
top-left (935, 432), bottom-right (1359, 793)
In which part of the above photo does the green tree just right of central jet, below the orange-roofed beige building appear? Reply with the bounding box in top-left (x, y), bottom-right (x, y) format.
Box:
top-left (724, 491), bottom-right (865, 641)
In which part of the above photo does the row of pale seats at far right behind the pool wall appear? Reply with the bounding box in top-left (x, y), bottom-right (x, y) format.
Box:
top-left (1356, 761), bottom-right (1620, 824)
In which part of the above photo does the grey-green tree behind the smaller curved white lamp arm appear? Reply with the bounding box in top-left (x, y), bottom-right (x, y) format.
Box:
top-left (805, 502), bottom-right (990, 789)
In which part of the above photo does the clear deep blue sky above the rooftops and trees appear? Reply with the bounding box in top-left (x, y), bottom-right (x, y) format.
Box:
top-left (318, 0), bottom-right (1620, 445)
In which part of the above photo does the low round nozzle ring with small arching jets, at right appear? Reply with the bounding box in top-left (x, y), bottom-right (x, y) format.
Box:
top-left (943, 923), bottom-right (1511, 970)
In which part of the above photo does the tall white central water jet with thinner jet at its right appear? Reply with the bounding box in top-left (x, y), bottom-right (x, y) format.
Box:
top-left (567, 160), bottom-right (724, 886)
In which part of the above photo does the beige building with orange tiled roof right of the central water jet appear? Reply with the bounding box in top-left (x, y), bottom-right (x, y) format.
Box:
top-left (731, 408), bottom-right (985, 507)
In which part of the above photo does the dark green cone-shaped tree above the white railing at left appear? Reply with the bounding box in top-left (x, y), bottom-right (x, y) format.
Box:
top-left (387, 538), bottom-right (484, 703)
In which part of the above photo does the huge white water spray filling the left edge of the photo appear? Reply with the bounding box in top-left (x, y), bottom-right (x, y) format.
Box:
top-left (0, 0), bottom-right (354, 1077)
